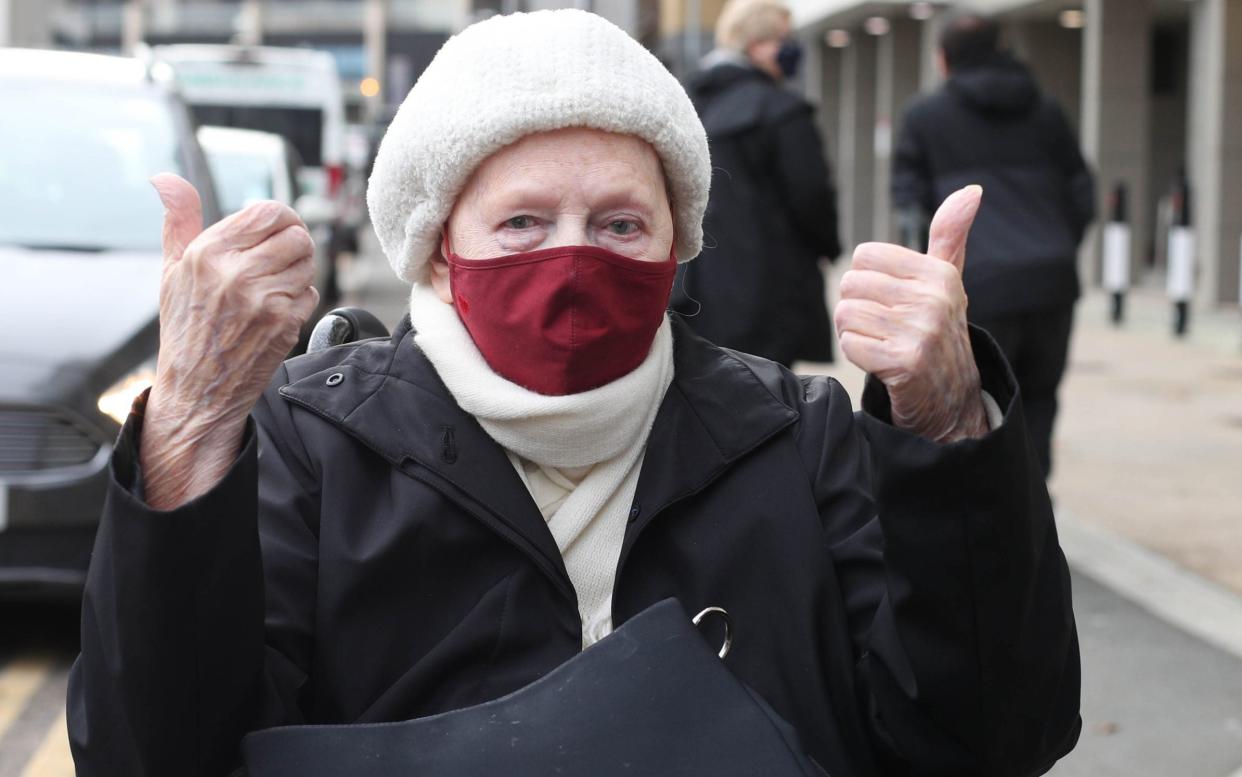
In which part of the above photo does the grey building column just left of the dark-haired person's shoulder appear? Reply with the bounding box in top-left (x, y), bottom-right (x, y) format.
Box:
top-left (868, 19), bottom-right (922, 242)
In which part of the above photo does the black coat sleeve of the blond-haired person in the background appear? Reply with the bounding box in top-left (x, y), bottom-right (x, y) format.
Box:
top-left (768, 103), bottom-right (841, 259)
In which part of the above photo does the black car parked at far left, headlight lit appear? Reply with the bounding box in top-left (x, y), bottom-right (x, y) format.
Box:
top-left (0, 48), bottom-right (219, 596)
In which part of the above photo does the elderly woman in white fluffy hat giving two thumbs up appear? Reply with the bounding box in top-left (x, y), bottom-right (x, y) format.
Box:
top-left (70, 11), bottom-right (1079, 777)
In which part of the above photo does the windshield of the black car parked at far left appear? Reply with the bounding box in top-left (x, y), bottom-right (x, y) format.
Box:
top-left (0, 82), bottom-right (181, 251)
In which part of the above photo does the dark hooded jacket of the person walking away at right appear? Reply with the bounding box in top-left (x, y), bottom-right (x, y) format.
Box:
top-left (892, 55), bottom-right (1095, 321)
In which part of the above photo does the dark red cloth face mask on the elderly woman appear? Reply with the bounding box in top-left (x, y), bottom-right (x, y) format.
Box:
top-left (445, 246), bottom-right (677, 396)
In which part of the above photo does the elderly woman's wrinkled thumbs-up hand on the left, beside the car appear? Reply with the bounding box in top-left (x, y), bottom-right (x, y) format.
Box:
top-left (140, 174), bottom-right (319, 509)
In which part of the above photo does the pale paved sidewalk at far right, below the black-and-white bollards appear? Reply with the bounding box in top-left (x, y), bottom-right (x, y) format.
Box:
top-left (1051, 294), bottom-right (1242, 593)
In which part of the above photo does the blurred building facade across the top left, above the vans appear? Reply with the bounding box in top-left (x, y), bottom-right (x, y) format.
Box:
top-left (24, 0), bottom-right (655, 120)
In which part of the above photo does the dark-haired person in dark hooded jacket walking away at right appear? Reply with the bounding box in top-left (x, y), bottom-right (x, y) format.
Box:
top-left (892, 15), bottom-right (1095, 474)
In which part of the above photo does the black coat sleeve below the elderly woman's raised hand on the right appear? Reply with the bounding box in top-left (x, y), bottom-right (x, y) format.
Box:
top-left (816, 329), bottom-right (1081, 777)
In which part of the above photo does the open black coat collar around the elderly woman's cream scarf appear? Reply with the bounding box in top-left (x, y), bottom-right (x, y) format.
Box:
top-left (279, 315), bottom-right (797, 597)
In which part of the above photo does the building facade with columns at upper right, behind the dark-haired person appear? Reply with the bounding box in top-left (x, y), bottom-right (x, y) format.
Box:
top-left (789, 0), bottom-right (1242, 307)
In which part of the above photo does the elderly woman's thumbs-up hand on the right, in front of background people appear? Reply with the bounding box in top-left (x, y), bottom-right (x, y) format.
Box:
top-left (835, 186), bottom-right (987, 442)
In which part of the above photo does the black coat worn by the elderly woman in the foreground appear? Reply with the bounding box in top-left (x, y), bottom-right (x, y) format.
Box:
top-left (68, 315), bottom-right (1079, 777)
